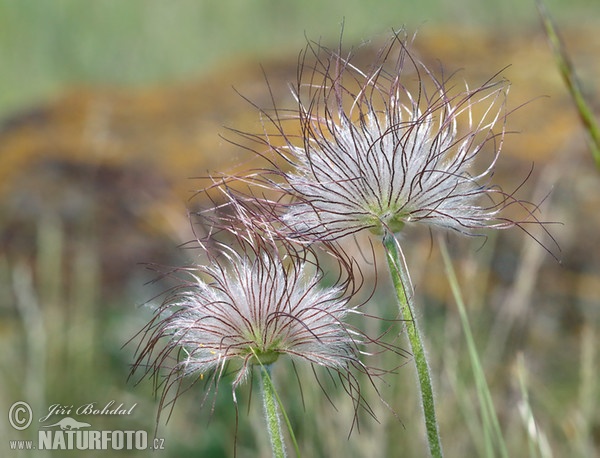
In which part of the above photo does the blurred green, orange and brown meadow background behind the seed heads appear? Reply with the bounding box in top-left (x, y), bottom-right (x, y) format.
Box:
top-left (0, 0), bottom-right (600, 457)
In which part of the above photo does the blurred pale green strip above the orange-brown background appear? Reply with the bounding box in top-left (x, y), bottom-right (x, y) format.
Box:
top-left (0, 0), bottom-right (598, 115)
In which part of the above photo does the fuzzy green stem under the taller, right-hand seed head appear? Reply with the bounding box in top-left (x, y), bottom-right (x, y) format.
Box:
top-left (383, 232), bottom-right (443, 458)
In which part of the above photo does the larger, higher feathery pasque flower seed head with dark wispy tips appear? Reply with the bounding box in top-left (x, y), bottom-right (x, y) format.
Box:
top-left (237, 31), bottom-right (530, 240)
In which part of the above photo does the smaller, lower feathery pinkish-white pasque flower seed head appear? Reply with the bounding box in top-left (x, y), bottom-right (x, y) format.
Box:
top-left (134, 202), bottom-right (378, 416)
